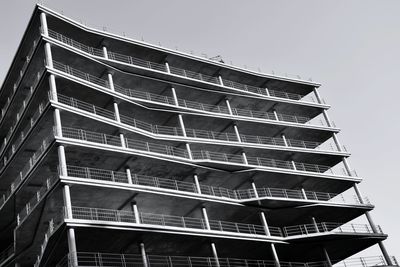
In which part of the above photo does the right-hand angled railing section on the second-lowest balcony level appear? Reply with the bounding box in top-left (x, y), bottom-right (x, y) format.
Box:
top-left (283, 222), bottom-right (383, 237)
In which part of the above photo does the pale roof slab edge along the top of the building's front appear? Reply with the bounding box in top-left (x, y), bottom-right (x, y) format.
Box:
top-left (36, 4), bottom-right (321, 87)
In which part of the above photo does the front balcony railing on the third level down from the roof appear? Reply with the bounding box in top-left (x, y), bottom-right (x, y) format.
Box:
top-left (58, 94), bottom-right (338, 154)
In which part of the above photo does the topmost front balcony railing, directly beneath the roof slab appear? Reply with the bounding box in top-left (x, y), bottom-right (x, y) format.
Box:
top-left (49, 30), bottom-right (318, 103)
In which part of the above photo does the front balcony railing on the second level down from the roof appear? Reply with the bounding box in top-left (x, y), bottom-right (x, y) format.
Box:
top-left (53, 61), bottom-right (329, 127)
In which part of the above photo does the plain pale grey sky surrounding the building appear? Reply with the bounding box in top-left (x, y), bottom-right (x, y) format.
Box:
top-left (0, 0), bottom-right (400, 262)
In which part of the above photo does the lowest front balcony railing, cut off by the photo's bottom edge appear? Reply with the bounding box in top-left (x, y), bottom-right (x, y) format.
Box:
top-left (56, 252), bottom-right (398, 267)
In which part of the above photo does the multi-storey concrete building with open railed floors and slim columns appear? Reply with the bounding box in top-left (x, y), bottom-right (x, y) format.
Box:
top-left (0, 5), bottom-right (397, 267)
